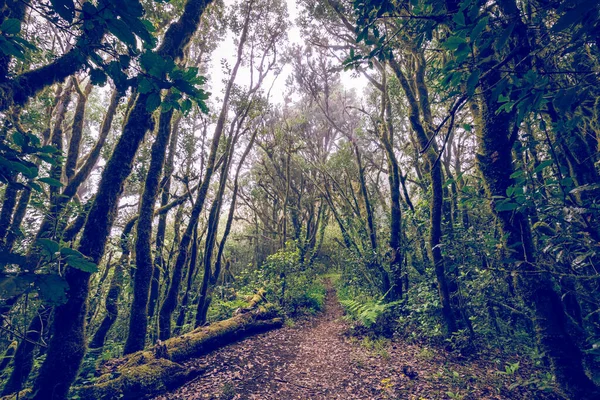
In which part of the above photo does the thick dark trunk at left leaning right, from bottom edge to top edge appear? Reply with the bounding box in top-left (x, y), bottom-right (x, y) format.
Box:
top-left (28, 0), bottom-right (216, 400)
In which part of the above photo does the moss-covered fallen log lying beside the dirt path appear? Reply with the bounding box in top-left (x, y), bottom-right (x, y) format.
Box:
top-left (72, 302), bottom-right (283, 400)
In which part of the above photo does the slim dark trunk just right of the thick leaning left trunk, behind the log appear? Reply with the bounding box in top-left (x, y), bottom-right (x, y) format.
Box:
top-left (123, 109), bottom-right (173, 354)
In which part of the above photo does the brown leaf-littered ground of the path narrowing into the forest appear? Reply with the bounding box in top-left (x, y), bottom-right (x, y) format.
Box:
top-left (155, 287), bottom-right (557, 400)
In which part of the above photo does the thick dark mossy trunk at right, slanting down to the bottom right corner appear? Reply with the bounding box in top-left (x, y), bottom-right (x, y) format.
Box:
top-left (477, 36), bottom-right (598, 399)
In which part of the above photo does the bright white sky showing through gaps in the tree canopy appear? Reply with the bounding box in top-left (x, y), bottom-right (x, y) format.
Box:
top-left (208, 0), bottom-right (367, 104)
